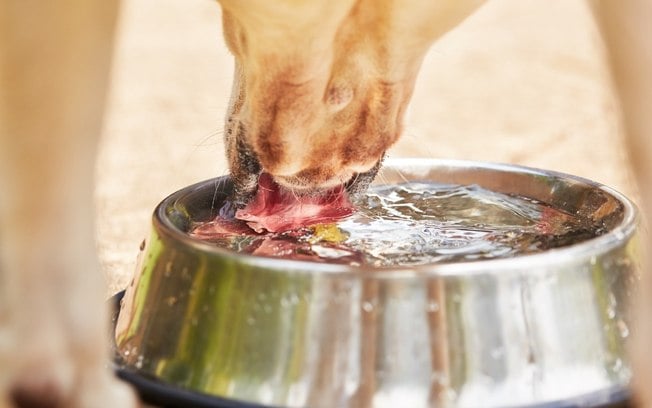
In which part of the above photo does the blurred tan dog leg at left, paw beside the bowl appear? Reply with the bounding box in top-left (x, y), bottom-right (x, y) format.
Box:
top-left (0, 0), bottom-right (135, 407)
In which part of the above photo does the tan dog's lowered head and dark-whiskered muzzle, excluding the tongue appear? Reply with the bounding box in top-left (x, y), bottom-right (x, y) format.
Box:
top-left (220, 0), bottom-right (481, 202)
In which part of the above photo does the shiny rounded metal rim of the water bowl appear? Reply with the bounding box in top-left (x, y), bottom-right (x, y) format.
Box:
top-left (152, 158), bottom-right (639, 279)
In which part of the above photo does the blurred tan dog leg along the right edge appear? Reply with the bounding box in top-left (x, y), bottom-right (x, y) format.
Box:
top-left (593, 0), bottom-right (652, 407)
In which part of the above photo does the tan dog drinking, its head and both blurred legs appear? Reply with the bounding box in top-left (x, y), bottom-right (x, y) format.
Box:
top-left (0, 0), bottom-right (652, 408)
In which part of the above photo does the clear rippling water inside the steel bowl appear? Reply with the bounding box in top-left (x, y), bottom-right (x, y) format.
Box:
top-left (191, 182), bottom-right (602, 266)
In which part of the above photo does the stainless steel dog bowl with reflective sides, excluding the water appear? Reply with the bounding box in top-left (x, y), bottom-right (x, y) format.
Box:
top-left (116, 159), bottom-right (638, 408)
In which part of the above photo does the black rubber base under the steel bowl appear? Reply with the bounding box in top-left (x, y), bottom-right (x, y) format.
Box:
top-left (110, 291), bottom-right (634, 408)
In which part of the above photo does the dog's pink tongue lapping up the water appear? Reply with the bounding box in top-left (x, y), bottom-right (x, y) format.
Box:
top-left (235, 173), bottom-right (355, 232)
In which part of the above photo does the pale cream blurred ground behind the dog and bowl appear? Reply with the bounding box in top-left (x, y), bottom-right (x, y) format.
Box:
top-left (96, 0), bottom-right (637, 293)
